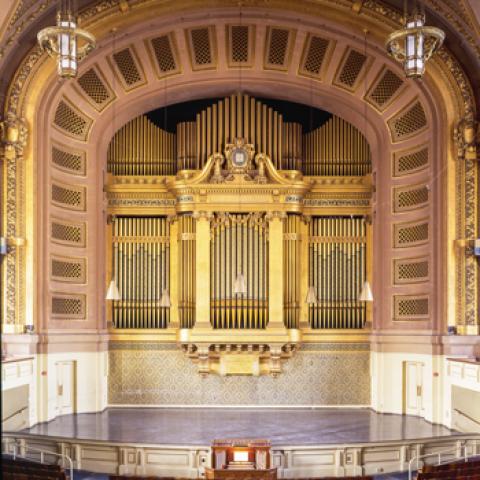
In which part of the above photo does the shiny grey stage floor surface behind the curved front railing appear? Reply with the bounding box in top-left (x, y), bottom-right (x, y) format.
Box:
top-left (22, 408), bottom-right (457, 446)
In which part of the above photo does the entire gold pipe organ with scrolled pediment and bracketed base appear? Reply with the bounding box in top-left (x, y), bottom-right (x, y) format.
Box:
top-left (105, 94), bottom-right (373, 374)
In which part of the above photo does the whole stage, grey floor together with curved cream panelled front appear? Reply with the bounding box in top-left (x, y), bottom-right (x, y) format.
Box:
top-left (3, 408), bottom-right (480, 478)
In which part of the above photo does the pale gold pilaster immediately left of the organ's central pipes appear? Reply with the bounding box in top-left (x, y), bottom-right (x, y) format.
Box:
top-left (193, 212), bottom-right (212, 328)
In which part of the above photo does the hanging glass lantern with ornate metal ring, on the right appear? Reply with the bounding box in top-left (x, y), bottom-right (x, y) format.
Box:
top-left (385, 0), bottom-right (445, 78)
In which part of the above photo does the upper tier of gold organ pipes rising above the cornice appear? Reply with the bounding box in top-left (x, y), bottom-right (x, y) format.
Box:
top-left (107, 93), bottom-right (371, 176)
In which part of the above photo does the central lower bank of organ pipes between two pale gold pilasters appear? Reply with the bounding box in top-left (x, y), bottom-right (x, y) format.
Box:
top-left (210, 213), bottom-right (268, 328)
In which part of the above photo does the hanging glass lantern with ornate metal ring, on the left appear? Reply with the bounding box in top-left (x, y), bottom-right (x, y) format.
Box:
top-left (37, 0), bottom-right (96, 78)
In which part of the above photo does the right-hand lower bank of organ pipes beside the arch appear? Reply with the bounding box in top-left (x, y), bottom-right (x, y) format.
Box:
top-left (308, 216), bottom-right (366, 328)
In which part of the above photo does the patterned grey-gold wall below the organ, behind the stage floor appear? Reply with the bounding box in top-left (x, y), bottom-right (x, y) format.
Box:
top-left (108, 343), bottom-right (370, 406)
